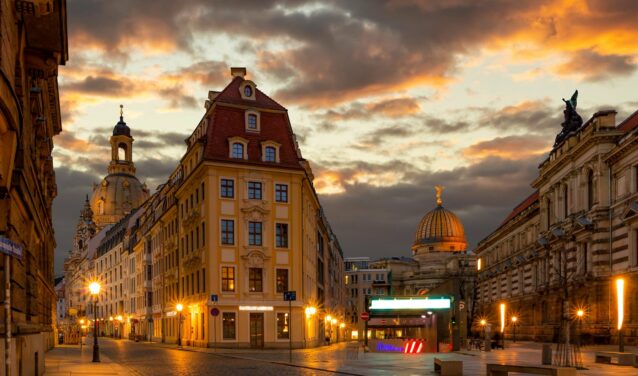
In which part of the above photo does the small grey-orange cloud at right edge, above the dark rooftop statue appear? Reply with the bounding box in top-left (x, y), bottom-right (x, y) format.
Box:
top-left (556, 49), bottom-right (637, 81)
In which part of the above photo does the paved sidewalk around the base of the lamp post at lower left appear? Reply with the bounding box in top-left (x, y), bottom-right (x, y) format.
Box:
top-left (44, 345), bottom-right (135, 376)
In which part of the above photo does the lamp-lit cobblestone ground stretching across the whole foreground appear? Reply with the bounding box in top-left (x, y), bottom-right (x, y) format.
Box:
top-left (47, 338), bottom-right (638, 376)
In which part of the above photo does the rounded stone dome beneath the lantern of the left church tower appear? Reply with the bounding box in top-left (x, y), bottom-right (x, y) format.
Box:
top-left (90, 173), bottom-right (149, 228)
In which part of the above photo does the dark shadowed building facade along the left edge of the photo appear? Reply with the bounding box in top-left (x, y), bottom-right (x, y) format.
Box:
top-left (0, 0), bottom-right (68, 375)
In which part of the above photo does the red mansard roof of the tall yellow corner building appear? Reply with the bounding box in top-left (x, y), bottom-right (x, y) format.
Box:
top-left (205, 77), bottom-right (303, 170)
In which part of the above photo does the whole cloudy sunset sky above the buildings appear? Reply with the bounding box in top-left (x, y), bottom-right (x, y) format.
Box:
top-left (53, 0), bottom-right (638, 274)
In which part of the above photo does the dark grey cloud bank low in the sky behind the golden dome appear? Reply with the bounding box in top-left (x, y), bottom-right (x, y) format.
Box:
top-left (318, 157), bottom-right (538, 257)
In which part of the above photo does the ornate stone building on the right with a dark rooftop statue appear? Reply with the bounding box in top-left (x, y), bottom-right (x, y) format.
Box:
top-left (475, 103), bottom-right (638, 343)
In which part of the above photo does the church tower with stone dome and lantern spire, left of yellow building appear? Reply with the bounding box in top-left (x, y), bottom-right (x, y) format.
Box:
top-left (90, 105), bottom-right (149, 230)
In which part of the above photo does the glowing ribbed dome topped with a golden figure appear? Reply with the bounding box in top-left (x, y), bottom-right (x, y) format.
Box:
top-left (412, 187), bottom-right (467, 253)
